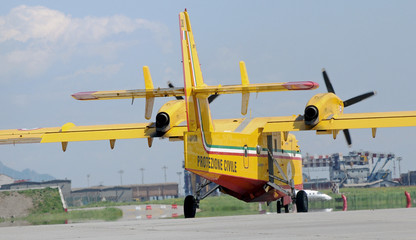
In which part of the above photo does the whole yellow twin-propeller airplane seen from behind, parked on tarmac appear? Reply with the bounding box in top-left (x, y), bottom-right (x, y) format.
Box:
top-left (0, 10), bottom-right (416, 218)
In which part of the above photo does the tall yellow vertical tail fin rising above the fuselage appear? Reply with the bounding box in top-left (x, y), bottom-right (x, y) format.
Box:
top-left (179, 11), bottom-right (214, 131)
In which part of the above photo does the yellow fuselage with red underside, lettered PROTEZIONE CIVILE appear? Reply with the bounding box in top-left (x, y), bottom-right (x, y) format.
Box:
top-left (184, 119), bottom-right (303, 202)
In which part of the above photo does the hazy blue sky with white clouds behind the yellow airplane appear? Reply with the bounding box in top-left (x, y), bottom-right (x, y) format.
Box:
top-left (0, 0), bottom-right (416, 187)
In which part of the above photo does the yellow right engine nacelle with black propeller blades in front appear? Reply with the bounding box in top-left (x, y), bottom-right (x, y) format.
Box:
top-left (304, 93), bottom-right (344, 126)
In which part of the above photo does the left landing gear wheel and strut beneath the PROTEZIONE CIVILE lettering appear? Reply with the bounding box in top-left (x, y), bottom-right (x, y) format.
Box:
top-left (183, 179), bottom-right (219, 218)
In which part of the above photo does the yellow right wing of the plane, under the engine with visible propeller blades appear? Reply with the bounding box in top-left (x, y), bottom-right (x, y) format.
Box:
top-left (258, 111), bottom-right (416, 133)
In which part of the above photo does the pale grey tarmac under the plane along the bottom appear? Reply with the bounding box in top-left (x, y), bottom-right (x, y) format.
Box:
top-left (0, 208), bottom-right (416, 240)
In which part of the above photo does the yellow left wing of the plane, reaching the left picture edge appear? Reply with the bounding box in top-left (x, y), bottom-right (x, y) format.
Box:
top-left (0, 123), bottom-right (186, 151)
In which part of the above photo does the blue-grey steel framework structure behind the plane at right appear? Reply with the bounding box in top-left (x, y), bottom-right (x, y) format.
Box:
top-left (302, 151), bottom-right (406, 189)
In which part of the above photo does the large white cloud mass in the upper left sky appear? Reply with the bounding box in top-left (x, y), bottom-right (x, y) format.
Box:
top-left (0, 5), bottom-right (171, 78)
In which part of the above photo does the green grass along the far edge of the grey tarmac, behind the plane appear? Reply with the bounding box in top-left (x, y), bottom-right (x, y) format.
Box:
top-left (12, 186), bottom-right (416, 224)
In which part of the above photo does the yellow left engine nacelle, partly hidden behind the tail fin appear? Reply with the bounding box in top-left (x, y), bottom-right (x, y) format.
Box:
top-left (156, 100), bottom-right (186, 136)
